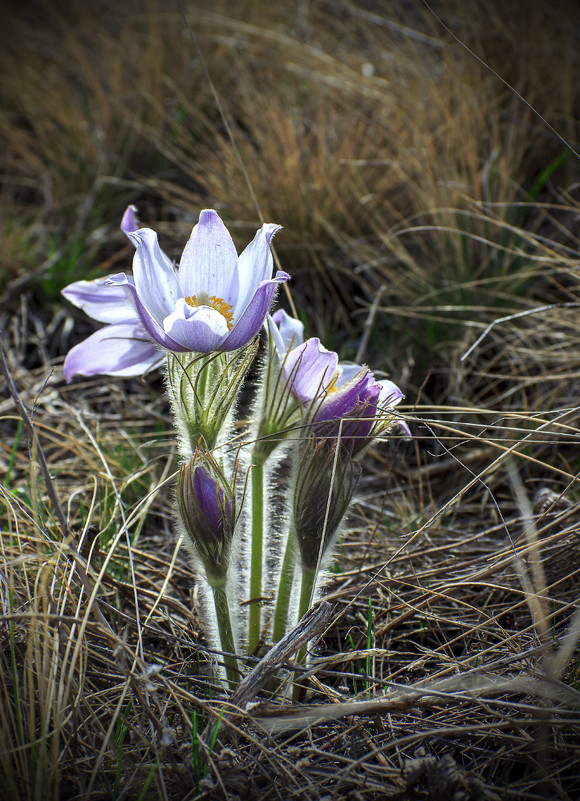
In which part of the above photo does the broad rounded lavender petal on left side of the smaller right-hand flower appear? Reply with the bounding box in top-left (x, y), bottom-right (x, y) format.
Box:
top-left (284, 337), bottom-right (338, 403)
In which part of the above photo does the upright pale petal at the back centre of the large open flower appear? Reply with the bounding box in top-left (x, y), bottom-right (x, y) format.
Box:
top-left (179, 209), bottom-right (238, 308)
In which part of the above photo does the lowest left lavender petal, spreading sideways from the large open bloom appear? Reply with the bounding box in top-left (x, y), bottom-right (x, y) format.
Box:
top-left (64, 323), bottom-right (164, 383)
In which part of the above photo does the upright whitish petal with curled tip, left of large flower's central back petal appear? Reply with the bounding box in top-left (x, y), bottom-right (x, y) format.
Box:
top-left (127, 228), bottom-right (180, 323)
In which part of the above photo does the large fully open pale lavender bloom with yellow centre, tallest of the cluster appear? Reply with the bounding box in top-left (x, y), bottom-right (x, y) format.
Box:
top-left (63, 206), bottom-right (289, 381)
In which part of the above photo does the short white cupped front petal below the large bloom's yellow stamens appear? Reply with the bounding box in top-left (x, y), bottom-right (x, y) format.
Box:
top-left (163, 298), bottom-right (228, 353)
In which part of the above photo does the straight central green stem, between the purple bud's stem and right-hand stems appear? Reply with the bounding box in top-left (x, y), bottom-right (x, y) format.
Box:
top-left (248, 454), bottom-right (264, 654)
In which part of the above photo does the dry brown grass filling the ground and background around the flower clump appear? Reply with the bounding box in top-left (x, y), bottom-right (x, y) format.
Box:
top-left (0, 0), bottom-right (580, 801)
